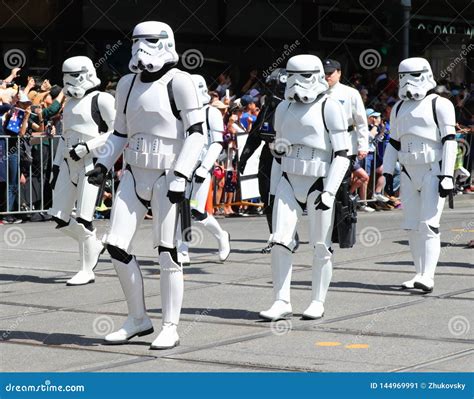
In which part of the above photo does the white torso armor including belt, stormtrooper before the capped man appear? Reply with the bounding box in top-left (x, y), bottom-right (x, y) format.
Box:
top-left (280, 101), bottom-right (332, 177)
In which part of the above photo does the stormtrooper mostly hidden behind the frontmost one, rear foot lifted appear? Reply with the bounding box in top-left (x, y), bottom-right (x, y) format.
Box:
top-left (178, 75), bottom-right (230, 263)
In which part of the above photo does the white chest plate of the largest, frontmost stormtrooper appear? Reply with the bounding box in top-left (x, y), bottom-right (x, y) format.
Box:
top-left (124, 70), bottom-right (184, 141)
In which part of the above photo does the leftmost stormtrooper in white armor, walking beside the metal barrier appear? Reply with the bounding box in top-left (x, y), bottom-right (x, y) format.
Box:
top-left (48, 56), bottom-right (115, 285)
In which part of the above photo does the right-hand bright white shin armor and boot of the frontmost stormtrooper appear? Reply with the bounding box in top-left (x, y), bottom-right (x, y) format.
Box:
top-left (150, 252), bottom-right (184, 349)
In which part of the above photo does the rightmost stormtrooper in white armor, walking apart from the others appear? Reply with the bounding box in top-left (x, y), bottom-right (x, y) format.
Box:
top-left (383, 58), bottom-right (457, 292)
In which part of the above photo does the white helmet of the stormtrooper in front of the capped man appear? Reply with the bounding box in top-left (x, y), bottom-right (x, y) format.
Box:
top-left (285, 54), bottom-right (329, 104)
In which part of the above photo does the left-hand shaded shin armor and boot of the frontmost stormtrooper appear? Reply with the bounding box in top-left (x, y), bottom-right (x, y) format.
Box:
top-left (105, 257), bottom-right (153, 345)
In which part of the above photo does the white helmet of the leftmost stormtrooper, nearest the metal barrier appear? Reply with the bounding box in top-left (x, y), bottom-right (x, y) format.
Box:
top-left (63, 55), bottom-right (100, 98)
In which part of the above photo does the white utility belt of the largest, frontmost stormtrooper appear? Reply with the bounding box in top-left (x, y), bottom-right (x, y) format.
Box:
top-left (124, 133), bottom-right (182, 169)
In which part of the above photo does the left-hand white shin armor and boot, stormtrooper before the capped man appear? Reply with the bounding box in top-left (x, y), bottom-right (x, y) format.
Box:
top-left (260, 245), bottom-right (293, 321)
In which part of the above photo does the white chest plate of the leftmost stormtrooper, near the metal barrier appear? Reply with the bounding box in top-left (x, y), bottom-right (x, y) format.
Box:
top-left (63, 91), bottom-right (100, 148)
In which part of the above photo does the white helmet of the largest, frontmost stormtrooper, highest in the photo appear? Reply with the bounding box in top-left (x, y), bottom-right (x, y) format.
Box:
top-left (128, 21), bottom-right (178, 73)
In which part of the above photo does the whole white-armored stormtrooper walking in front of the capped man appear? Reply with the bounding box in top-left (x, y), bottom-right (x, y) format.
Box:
top-left (260, 55), bottom-right (350, 320)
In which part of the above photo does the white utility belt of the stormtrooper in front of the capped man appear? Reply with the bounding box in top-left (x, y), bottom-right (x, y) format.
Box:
top-left (281, 145), bottom-right (330, 177)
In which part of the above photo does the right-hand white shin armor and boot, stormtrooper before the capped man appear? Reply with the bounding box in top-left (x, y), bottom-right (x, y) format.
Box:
top-left (303, 243), bottom-right (332, 319)
